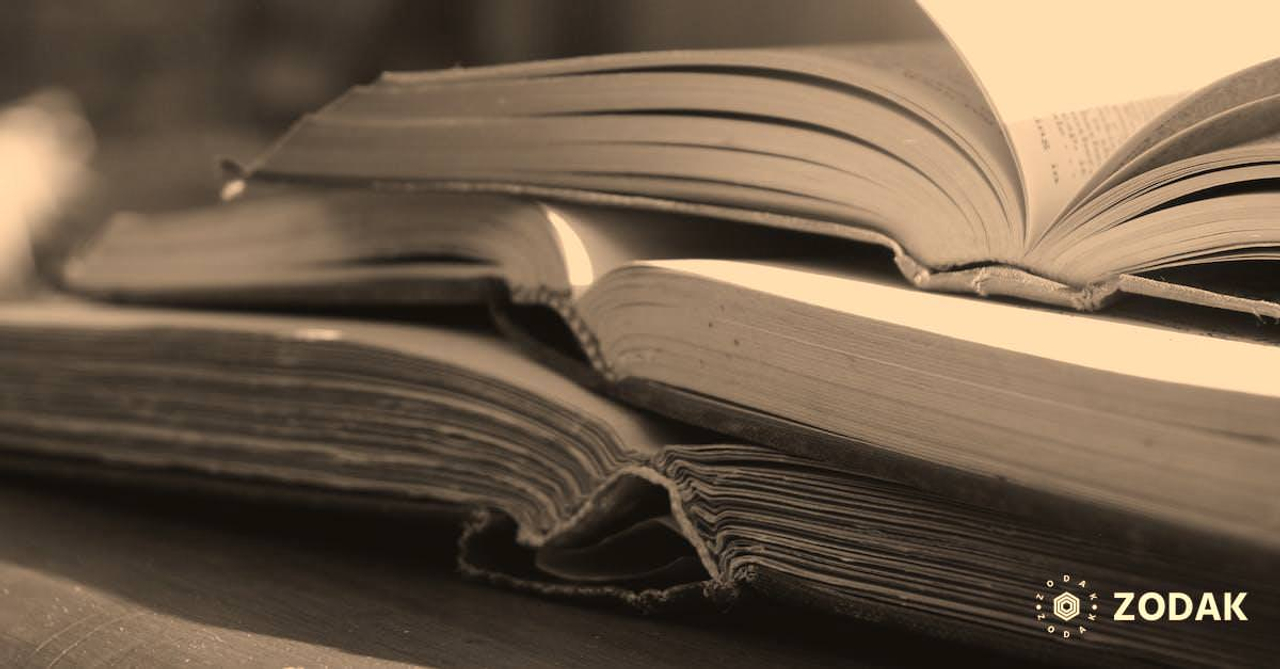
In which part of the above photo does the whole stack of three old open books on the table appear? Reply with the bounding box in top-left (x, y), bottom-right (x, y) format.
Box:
top-left (0, 6), bottom-right (1280, 664)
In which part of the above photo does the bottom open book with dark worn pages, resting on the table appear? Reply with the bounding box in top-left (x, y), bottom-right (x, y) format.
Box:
top-left (0, 299), bottom-right (1280, 665)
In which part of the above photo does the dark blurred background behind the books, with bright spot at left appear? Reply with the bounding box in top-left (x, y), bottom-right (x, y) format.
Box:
top-left (0, 0), bottom-right (932, 285)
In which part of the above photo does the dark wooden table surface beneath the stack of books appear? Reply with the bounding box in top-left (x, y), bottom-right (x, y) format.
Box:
top-left (0, 460), bottom-right (1018, 668)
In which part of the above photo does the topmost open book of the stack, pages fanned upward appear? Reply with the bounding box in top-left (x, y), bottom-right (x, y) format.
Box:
top-left (74, 3), bottom-right (1280, 316)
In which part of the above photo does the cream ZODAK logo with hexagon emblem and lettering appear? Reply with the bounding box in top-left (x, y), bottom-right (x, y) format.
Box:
top-left (1036, 574), bottom-right (1249, 638)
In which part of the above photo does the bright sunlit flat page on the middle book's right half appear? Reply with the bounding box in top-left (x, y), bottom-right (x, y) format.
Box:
top-left (644, 260), bottom-right (1280, 398)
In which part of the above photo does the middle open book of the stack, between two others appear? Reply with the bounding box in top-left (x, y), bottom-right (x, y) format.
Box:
top-left (65, 193), bottom-right (1280, 565)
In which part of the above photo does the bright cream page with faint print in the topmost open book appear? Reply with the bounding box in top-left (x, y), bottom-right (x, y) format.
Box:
top-left (919, 0), bottom-right (1280, 238)
